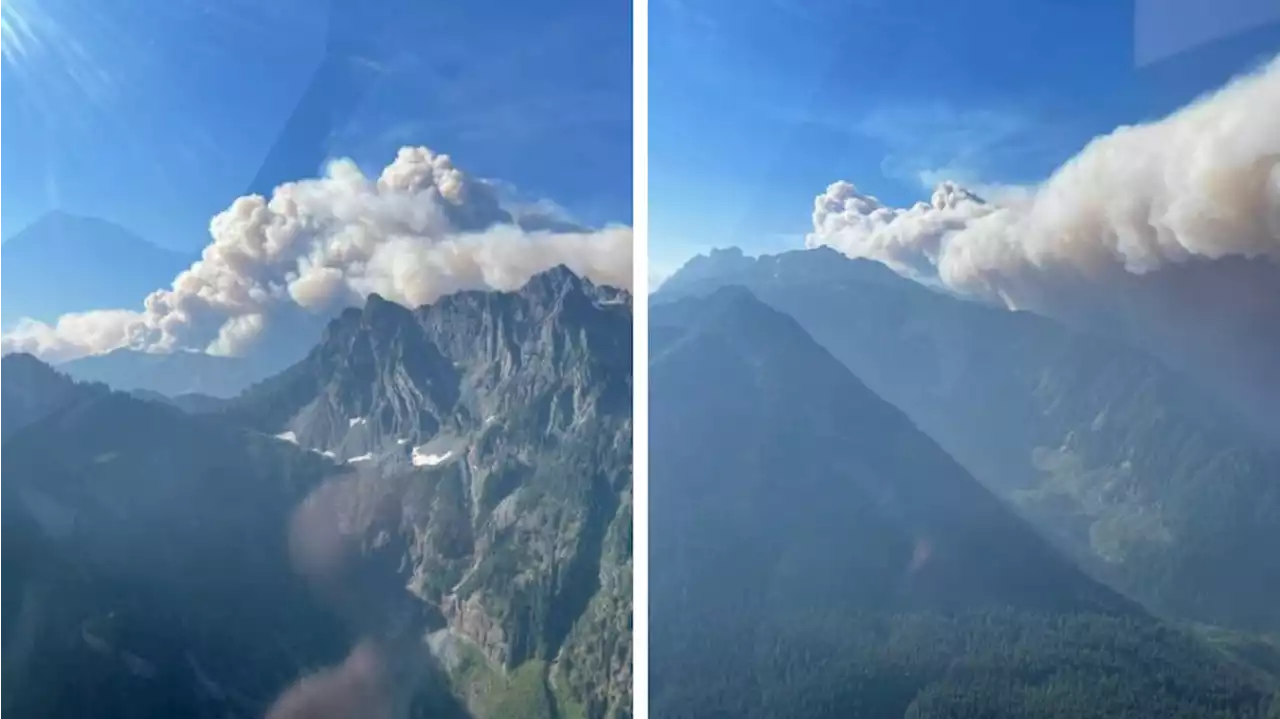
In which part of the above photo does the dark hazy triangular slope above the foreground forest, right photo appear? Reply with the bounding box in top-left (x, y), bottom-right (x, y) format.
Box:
top-left (650, 288), bottom-right (1137, 613)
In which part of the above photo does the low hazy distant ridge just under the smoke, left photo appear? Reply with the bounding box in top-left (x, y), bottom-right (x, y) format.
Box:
top-left (58, 349), bottom-right (287, 399)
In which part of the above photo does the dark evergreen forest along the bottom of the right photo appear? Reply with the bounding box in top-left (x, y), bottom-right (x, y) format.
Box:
top-left (650, 612), bottom-right (1280, 719)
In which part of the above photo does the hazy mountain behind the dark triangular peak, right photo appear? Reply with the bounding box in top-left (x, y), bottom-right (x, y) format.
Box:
top-left (655, 248), bottom-right (1280, 629)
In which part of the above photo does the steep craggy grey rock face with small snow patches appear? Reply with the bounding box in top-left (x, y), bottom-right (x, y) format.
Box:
top-left (223, 267), bottom-right (631, 716)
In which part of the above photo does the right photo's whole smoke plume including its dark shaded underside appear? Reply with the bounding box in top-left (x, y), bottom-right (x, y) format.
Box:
top-left (806, 58), bottom-right (1280, 424)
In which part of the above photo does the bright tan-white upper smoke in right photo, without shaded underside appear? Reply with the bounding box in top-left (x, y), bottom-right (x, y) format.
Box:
top-left (808, 51), bottom-right (1280, 298)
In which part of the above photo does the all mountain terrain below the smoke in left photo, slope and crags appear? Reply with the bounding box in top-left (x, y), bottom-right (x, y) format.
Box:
top-left (0, 270), bottom-right (631, 719)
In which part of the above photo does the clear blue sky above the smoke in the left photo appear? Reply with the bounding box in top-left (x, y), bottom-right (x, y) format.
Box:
top-left (0, 0), bottom-right (631, 251)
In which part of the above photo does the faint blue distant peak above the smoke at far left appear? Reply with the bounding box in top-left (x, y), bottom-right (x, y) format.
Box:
top-left (0, 212), bottom-right (200, 329)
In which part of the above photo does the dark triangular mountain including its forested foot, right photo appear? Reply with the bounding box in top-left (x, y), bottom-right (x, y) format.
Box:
top-left (649, 287), bottom-right (1276, 719)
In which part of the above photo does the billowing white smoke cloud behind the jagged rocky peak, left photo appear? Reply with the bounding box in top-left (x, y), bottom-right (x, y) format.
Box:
top-left (0, 147), bottom-right (632, 362)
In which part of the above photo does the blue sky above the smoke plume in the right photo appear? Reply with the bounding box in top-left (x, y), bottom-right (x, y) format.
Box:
top-left (649, 0), bottom-right (1280, 278)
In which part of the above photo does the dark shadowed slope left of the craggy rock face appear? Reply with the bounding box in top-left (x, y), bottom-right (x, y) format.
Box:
top-left (0, 393), bottom-right (381, 718)
